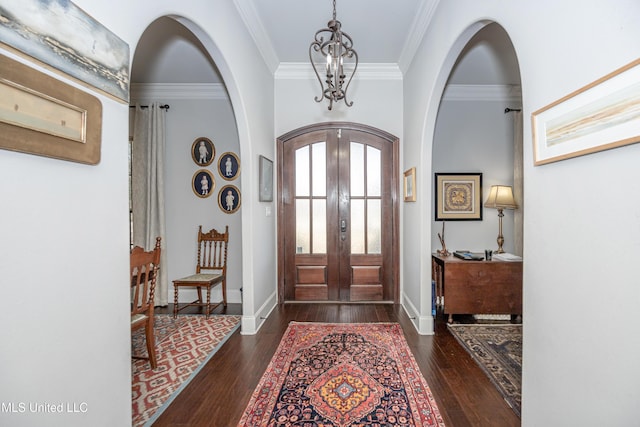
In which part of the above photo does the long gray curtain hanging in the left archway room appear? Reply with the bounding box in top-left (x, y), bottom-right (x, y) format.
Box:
top-left (131, 102), bottom-right (169, 306)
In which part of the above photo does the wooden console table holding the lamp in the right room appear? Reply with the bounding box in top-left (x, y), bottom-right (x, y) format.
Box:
top-left (432, 254), bottom-right (522, 323)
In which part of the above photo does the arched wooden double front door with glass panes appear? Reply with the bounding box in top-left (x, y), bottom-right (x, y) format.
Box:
top-left (278, 123), bottom-right (398, 302)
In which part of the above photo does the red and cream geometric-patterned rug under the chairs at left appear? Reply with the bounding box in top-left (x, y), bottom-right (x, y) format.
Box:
top-left (131, 314), bottom-right (240, 427)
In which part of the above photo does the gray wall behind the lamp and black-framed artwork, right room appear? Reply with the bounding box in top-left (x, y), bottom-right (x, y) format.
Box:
top-left (432, 100), bottom-right (514, 253)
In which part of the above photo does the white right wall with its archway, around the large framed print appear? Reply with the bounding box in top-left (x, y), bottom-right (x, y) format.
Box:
top-left (404, 0), bottom-right (640, 426)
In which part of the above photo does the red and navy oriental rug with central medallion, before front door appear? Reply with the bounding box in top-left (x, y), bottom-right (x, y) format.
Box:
top-left (238, 322), bottom-right (444, 427)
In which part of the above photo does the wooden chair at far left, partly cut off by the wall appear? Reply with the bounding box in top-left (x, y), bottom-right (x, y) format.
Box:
top-left (130, 237), bottom-right (161, 369)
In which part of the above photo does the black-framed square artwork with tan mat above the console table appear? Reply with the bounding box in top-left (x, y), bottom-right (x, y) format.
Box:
top-left (434, 173), bottom-right (482, 221)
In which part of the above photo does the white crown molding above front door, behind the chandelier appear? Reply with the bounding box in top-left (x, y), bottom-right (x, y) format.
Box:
top-left (274, 62), bottom-right (402, 80)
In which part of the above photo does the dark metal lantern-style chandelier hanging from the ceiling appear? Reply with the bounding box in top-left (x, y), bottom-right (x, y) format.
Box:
top-left (309, 0), bottom-right (358, 110)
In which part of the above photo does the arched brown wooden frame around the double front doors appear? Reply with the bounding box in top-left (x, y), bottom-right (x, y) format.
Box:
top-left (276, 122), bottom-right (400, 304)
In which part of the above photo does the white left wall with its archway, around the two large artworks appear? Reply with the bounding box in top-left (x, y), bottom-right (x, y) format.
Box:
top-left (0, 0), bottom-right (275, 427)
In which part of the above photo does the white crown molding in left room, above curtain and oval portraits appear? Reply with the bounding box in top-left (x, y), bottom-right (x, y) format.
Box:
top-left (131, 83), bottom-right (229, 103)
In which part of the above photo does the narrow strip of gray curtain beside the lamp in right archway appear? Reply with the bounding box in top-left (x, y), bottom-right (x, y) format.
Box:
top-left (513, 111), bottom-right (524, 256)
